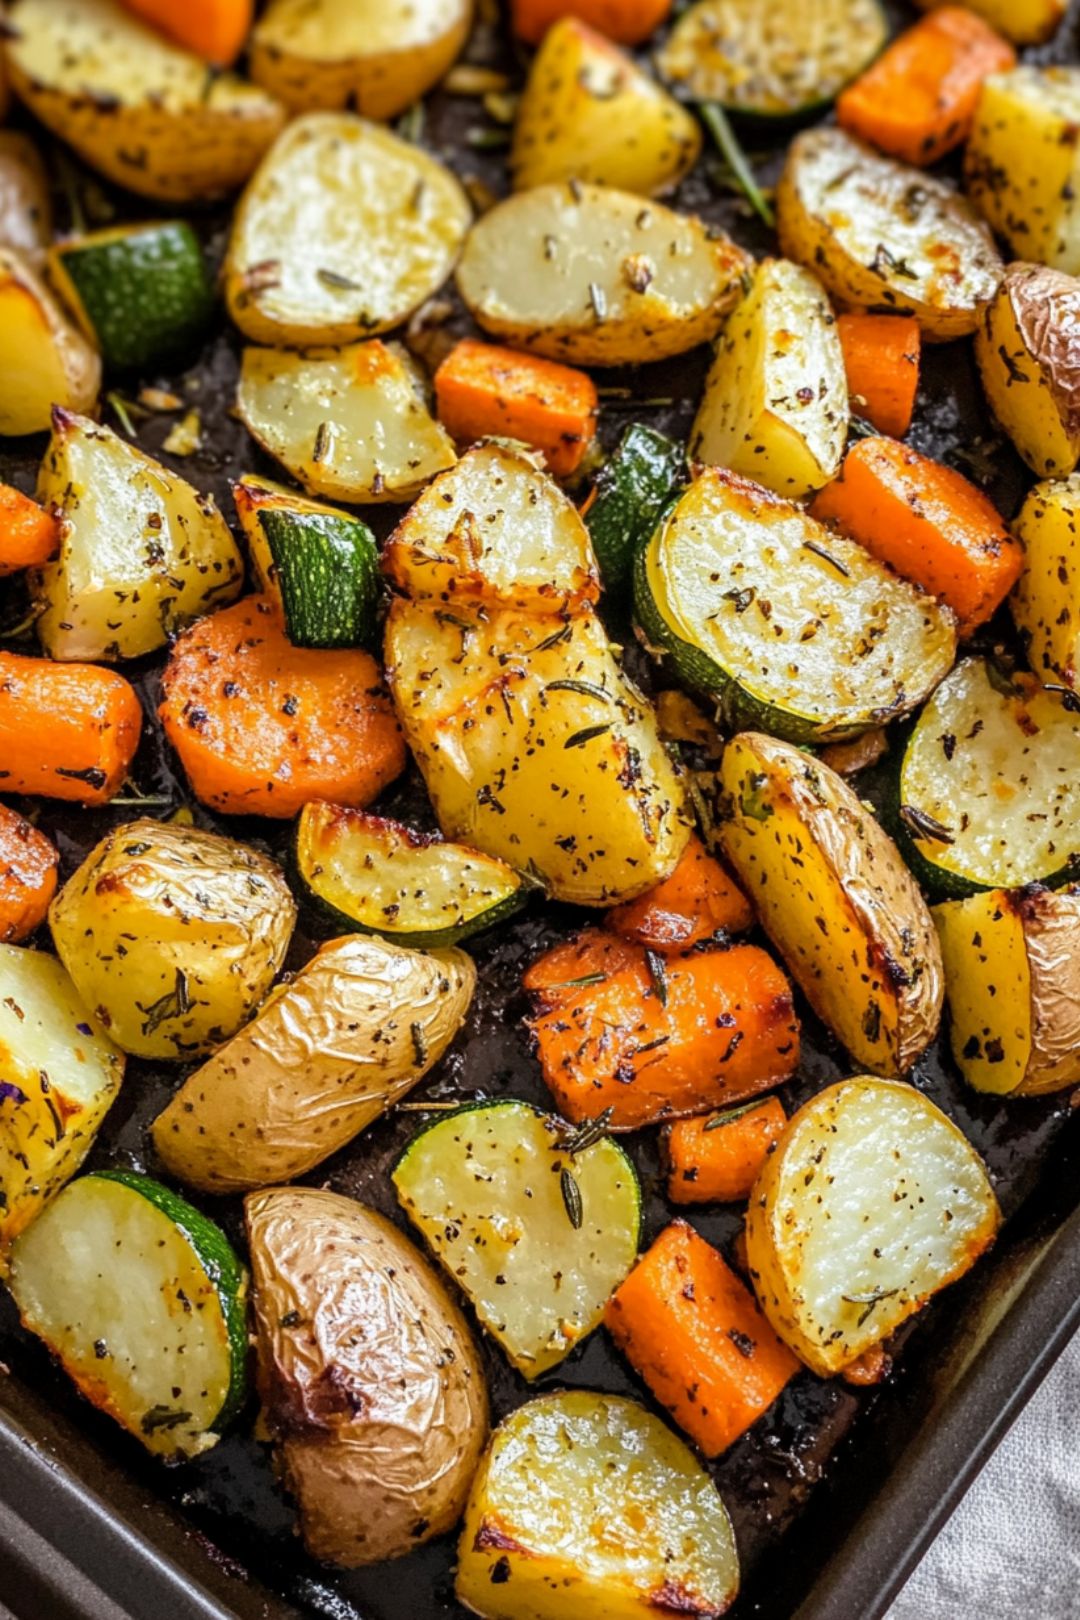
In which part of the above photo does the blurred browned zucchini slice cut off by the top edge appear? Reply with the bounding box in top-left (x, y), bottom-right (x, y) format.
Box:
top-left (657, 0), bottom-right (889, 118)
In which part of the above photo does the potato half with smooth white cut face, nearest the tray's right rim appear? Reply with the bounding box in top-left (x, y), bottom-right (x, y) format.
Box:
top-left (746, 1076), bottom-right (1001, 1379)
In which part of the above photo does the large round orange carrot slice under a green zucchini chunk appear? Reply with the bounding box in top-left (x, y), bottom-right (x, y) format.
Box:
top-left (159, 596), bottom-right (405, 818)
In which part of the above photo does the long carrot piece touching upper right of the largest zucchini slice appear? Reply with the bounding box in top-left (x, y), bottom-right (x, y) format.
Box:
top-left (810, 439), bottom-right (1023, 635)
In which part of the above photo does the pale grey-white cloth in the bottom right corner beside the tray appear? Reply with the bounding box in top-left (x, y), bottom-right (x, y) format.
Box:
top-left (886, 1335), bottom-right (1080, 1620)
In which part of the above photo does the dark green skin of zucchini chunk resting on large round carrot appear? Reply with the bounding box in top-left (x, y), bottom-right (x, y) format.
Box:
top-left (257, 507), bottom-right (381, 648)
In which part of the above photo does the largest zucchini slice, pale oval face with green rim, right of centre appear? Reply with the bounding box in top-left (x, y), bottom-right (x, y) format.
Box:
top-left (635, 468), bottom-right (957, 742)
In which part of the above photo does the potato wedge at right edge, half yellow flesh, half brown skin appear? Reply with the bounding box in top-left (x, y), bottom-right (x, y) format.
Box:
top-left (934, 885), bottom-right (1080, 1097)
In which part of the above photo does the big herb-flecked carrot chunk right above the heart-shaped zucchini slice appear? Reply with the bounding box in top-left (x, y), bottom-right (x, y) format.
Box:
top-left (525, 930), bottom-right (798, 1131)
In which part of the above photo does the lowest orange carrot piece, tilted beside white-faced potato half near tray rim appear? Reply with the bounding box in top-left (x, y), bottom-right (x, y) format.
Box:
top-left (604, 1220), bottom-right (800, 1456)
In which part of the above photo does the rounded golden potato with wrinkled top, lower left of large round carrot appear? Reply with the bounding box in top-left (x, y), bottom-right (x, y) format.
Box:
top-left (49, 821), bottom-right (296, 1059)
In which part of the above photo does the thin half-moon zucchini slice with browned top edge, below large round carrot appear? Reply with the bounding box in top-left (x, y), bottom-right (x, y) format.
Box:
top-left (296, 800), bottom-right (528, 949)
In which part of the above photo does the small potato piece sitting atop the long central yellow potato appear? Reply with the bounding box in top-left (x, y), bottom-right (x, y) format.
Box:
top-left (382, 442), bottom-right (599, 612)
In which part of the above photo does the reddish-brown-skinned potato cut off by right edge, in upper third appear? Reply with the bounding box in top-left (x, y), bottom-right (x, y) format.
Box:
top-left (975, 264), bottom-right (1080, 478)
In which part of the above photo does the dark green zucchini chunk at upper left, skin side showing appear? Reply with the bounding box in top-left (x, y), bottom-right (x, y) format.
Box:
top-left (49, 219), bottom-right (214, 371)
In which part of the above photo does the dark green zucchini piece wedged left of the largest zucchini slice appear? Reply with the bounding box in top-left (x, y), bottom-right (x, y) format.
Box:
top-left (585, 423), bottom-right (687, 590)
